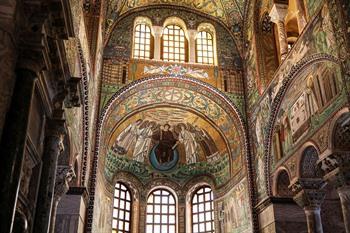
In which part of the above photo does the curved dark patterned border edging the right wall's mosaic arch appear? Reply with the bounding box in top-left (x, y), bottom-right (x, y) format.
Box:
top-left (264, 53), bottom-right (341, 196)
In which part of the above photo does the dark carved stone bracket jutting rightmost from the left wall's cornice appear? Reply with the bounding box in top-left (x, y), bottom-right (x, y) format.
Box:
top-left (64, 77), bottom-right (82, 108)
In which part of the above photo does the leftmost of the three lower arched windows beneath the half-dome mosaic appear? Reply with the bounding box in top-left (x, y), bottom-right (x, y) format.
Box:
top-left (112, 182), bottom-right (132, 233)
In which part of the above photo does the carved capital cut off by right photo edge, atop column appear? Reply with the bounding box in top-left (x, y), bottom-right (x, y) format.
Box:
top-left (318, 152), bottom-right (350, 188)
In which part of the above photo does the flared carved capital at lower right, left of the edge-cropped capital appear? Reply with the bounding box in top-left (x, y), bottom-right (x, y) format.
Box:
top-left (289, 178), bottom-right (326, 208)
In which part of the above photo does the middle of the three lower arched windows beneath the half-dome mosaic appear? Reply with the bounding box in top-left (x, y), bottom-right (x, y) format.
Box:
top-left (146, 189), bottom-right (176, 233)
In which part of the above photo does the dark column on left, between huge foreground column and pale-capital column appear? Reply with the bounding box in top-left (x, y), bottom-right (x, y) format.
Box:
top-left (34, 120), bottom-right (65, 233)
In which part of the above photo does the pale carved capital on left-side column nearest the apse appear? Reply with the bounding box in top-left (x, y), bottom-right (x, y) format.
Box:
top-left (55, 166), bottom-right (76, 200)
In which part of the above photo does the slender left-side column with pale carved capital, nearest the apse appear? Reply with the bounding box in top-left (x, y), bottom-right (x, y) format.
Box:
top-left (50, 165), bottom-right (75, 233)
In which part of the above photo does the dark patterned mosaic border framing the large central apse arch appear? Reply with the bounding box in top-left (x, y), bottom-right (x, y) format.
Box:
top-left (86, 75), bottom-right (254, 232)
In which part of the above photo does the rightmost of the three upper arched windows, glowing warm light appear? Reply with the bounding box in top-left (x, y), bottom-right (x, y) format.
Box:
top-left (196, 31), bottom-right (214, 64)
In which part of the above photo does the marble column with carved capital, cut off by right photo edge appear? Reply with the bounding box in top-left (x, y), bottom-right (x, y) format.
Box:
top-left (318, 151), bottom-right (350, 233)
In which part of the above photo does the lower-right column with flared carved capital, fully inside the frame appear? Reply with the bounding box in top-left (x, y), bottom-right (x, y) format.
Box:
top-left (290, 178), bottom-right (326, 233)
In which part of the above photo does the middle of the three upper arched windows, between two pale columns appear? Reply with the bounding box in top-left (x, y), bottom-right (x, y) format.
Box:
top-left (162, 24), bottom-right (187, 62)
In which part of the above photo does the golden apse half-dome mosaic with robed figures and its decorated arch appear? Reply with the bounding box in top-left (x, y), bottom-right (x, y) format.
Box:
top-left (99, 76), bottom-right (245, 186)
